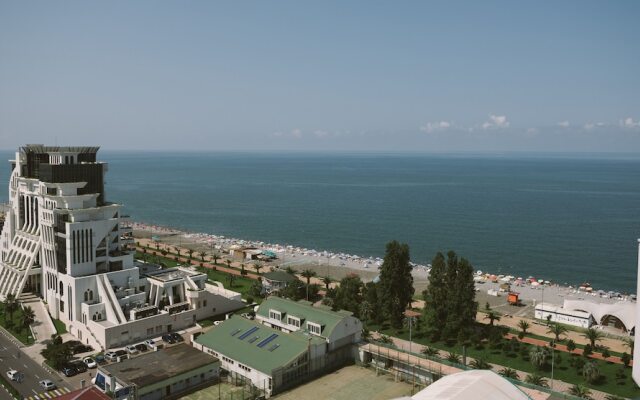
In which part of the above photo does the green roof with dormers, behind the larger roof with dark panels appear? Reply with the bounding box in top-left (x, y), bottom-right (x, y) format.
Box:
top-left (257, 296), bottom-right (352, 337)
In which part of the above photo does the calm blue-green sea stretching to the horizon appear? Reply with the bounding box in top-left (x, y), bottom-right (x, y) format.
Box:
top-left (0, 151), bottom-right (640, 293)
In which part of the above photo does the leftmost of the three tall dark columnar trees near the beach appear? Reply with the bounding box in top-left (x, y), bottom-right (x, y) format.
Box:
top-left (380, 240), bottom-right (415, 329)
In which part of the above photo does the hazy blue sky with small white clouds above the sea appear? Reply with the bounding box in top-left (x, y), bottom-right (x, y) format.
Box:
top-left (0, 1), bottom-right (640, 152)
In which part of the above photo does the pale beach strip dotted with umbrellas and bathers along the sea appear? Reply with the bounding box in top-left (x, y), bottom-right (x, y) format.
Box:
top-left (130, 221), bottom-right (632, 308)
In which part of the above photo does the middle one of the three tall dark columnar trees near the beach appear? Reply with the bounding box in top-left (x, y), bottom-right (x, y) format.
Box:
top-left (423, 252), bottom-right (448, 340)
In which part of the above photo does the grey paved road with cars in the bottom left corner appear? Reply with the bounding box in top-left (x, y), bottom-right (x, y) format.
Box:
top-left (0, 332), bottom-right (71, 400)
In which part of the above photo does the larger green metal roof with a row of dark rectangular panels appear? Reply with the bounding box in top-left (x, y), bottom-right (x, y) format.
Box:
top-left (196, 315), bottom-right (317, 375)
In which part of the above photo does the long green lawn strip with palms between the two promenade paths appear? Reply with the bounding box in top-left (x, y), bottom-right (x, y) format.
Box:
top-left (367, 324), bottom-right (640, 398)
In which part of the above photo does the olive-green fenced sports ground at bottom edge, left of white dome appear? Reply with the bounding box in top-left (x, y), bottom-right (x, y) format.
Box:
top-left (272, 366), bottom-right (420, 400)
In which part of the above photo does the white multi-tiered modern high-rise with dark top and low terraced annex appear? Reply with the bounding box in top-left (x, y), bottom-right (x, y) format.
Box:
top-left (0, 145), bottom-right (242, 349)
